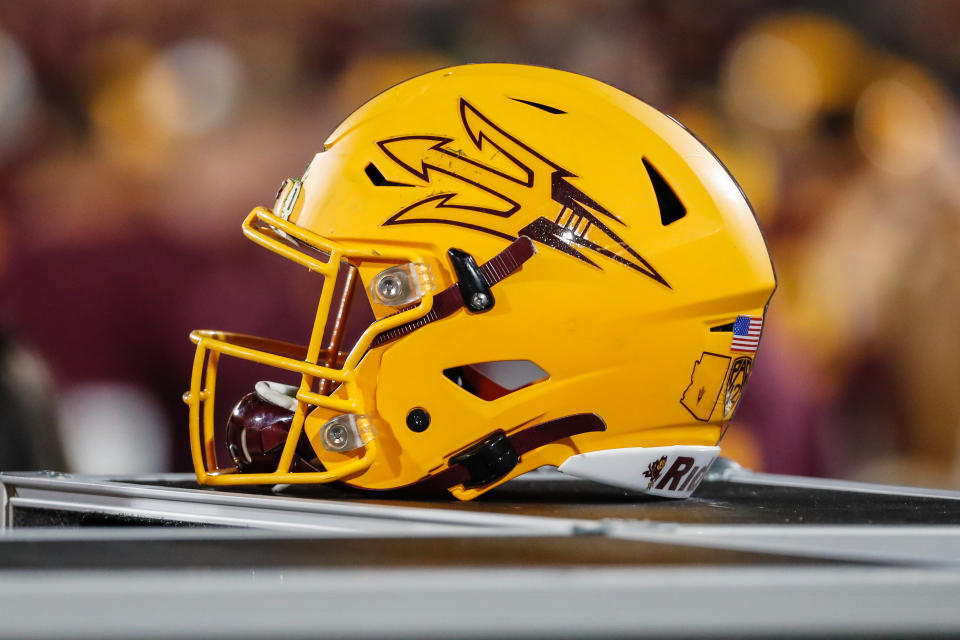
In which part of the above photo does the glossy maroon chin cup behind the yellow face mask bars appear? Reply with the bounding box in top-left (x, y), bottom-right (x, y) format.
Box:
top-left (226, 393), bottom-right (322, 473)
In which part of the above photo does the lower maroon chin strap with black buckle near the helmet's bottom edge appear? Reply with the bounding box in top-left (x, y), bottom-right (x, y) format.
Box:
top-left (404, 413), bottom-right (607, 492)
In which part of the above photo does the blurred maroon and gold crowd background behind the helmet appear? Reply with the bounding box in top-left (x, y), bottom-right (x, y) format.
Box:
top-left (0, 0), bottom-right (960, 488)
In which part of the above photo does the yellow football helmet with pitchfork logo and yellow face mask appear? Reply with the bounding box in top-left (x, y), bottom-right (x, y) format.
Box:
top-left (184, 64), bottom-right (775, 499)
